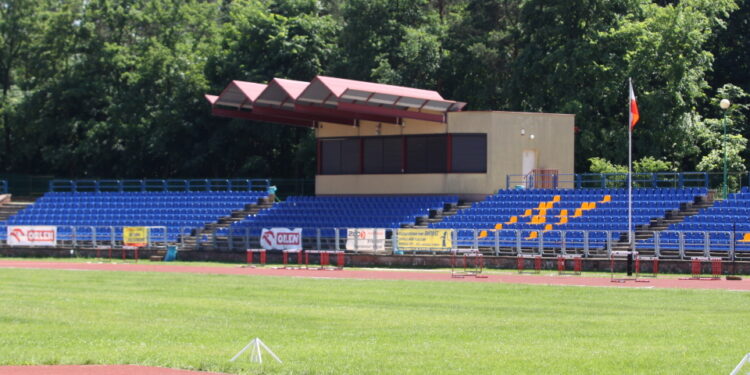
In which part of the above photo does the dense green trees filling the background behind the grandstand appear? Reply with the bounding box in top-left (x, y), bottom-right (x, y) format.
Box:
top-left (0, 0), bottom-right (750, 178)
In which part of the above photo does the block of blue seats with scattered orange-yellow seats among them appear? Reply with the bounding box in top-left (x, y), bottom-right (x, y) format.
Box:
top-left (430, 188), bottom-right (705, 247)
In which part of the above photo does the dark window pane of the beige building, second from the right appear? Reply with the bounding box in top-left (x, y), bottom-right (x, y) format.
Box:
top-left (406, 134), bottom-right (446, 173)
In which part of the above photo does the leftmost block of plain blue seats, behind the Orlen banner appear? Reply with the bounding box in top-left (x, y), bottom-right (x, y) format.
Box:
top-left (0, 179), bottom-right (269, 246)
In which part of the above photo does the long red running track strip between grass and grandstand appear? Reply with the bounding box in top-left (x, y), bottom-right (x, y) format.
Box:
top-left (0, 260), bottom-right (750, 291)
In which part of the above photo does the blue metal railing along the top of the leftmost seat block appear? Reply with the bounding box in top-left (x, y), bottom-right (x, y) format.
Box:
top-left (49, 179), bottom-right (271, 193)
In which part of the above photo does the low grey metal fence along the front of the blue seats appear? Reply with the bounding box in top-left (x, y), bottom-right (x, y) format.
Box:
top-left (5, 226), bottom-right (750, 260)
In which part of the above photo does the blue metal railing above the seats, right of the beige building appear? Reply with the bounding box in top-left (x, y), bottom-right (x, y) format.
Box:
top-left (505, 172), bottom-right (709, 189)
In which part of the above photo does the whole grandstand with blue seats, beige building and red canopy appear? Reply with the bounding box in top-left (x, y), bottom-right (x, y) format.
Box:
top-left (0, 76), bottom-right (750, 268)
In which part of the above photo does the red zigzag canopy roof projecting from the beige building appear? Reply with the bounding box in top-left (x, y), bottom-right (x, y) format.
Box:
top-left (206, 76), bottom-right (466, 126)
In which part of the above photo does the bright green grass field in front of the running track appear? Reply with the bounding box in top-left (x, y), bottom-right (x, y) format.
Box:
top-left (0, 269), bottom-right (750, 374)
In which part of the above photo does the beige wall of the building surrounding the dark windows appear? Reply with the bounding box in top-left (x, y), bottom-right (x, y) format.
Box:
top-left (315, 111), bottom-right (575, 199)
